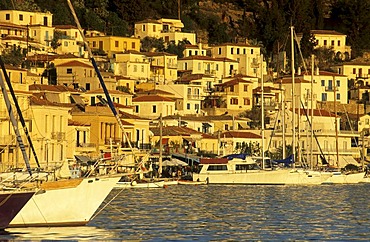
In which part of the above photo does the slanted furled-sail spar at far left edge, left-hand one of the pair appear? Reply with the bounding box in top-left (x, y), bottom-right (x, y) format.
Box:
top-left (0, 62), bottom-right (32, 176)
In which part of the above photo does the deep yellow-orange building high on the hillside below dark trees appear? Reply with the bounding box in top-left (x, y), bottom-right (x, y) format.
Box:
top-left (86, 36), bottom-right (140, 58)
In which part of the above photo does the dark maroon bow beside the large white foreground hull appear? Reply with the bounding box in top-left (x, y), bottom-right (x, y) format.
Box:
top-left (0, 191), bottom-right (35, 230)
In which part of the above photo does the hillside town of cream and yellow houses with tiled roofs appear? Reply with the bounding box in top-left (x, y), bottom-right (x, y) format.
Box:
top-left (0, 10), bottom-right (370, 174)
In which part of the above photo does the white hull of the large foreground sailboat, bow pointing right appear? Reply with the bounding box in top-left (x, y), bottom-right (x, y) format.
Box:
top-left (10, 177), bottom-right (120, 227)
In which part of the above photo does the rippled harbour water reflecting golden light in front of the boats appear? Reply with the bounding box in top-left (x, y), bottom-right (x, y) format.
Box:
top-left (0, 184), bottom-right (370, 241)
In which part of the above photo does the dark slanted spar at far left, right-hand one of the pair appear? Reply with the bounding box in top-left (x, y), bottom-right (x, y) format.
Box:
top-left (0, 57), bottom-right (40, 167)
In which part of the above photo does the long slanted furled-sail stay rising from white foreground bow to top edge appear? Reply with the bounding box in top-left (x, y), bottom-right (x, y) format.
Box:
top-left (67, 0), bottom-right (135, 157)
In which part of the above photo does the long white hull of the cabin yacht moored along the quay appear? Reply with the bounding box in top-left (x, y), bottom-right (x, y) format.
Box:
top-left (193, 169), bottom-right (330, 185)
